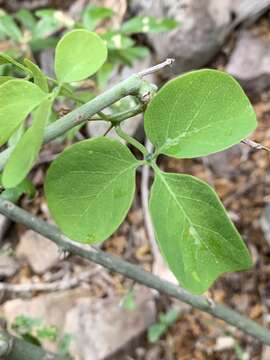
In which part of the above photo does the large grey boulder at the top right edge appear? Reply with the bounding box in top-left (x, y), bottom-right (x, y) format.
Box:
top-left (131, 0), bottom-right (270, 74)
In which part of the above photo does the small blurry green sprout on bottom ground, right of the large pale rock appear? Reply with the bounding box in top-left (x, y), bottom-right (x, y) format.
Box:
top-left (147, 309), bottom-right (179, 343)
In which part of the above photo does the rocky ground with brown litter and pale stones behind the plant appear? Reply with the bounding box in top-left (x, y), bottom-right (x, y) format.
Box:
top-left (0, 0), bottom-right (270, 360)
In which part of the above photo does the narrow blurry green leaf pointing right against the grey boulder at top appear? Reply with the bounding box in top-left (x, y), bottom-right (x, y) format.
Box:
top-left (121, 16), bottom-right (179, 34)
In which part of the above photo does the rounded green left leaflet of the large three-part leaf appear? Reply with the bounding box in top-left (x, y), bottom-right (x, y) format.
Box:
top-left (45, 137), bottom-right (140, 243)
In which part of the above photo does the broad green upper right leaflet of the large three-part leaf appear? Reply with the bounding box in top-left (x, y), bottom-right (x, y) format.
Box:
top-left (145, 70), bottom-right (256, 158)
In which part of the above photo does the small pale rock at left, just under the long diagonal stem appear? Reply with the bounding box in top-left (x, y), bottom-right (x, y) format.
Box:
top-left (16, 230), bottom-right (59, 274)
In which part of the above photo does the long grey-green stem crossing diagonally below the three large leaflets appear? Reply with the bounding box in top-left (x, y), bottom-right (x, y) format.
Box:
top-left (0, 197), bottom-right (270, 345)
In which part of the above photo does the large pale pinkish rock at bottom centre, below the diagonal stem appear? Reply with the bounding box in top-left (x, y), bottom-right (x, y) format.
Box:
top-left (65, 288), bottom-right (156, 360)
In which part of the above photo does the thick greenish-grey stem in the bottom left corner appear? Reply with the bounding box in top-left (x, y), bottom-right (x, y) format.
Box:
top-left (0, 330), bottom-right (71, 360)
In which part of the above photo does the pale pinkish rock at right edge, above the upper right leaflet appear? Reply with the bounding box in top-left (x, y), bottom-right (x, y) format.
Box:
top-left (226, 31), bottom-right (270, 94)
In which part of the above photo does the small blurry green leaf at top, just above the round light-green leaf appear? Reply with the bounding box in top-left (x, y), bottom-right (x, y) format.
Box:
top-left (83, 5), bottom-right (114, 30)
